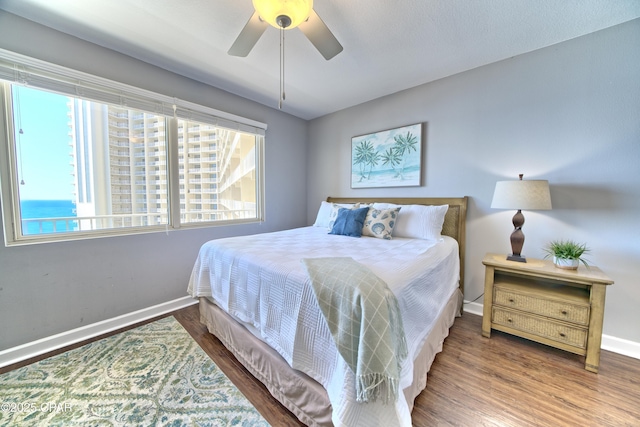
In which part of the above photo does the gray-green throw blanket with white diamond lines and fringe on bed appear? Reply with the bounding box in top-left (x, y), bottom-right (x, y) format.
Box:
top-left (302, 257), bottom-right (407, 403)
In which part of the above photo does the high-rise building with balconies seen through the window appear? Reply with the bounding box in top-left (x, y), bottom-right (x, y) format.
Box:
top-left (68, 99), bottom-right (256, 229)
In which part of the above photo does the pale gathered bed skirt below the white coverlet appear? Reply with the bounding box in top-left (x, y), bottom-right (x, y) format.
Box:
top-left (200, 291), bottom-right (462, 427)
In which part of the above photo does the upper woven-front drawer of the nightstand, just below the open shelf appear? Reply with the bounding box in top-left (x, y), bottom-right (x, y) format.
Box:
top-left (493, 284), bottom-right (589, 326)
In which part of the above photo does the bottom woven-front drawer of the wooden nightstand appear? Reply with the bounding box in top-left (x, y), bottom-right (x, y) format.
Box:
top-left (492, 307), bottom-right (587, 349)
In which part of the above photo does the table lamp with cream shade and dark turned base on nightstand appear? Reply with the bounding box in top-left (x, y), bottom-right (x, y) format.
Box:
top-left (491, 174), bottom-right (551, 262)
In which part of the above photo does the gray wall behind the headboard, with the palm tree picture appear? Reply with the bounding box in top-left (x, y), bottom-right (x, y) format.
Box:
top-left (307, 20), bottom-right (640, 343)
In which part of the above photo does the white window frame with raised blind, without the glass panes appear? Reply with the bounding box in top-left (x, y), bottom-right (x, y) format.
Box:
top-left (0, 49), bottom-right (267, 246)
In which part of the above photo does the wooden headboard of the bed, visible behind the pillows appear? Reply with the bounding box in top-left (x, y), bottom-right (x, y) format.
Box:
top-left (327, 196), bottom-right (469, 294)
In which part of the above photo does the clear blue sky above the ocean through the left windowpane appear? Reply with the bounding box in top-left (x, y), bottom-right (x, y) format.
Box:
top-left (13, 86), bottom-right (74, 200)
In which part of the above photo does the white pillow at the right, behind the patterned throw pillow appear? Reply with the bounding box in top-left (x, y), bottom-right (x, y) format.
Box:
top-left (373, 203), bottom-right (449, 240)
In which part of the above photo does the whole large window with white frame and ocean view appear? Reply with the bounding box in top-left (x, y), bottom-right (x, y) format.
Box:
top-left (0, 50), bottom-right (265, 244)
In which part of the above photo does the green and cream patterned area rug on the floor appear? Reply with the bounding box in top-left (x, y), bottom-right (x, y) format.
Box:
top-left (0, 317), bottom-right (269, 427)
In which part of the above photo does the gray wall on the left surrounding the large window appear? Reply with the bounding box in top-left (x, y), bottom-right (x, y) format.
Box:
top-left (0, 11), bottom-right (308, 350)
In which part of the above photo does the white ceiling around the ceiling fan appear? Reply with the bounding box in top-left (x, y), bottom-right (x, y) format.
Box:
top-left (0, 0), bottom-right (640, 119)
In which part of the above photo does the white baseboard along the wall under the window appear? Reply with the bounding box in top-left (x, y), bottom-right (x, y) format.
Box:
top-left (0, 296), bottom-right (198, 367)
